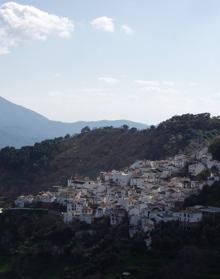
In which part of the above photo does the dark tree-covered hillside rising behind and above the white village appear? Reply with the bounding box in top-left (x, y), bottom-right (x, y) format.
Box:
top-left (0, 113), bottom-right (220, 199)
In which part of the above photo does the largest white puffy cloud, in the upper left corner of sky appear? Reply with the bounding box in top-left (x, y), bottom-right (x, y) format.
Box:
top-left (0, 2), bottom-right (74, 54)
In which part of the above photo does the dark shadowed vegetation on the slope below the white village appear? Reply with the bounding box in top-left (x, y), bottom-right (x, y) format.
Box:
top-left (0, 212), bottom-right (220, 279)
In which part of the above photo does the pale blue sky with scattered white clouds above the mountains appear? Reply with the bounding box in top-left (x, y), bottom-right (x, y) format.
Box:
top-left (0, 0), bottom-right (220, 124)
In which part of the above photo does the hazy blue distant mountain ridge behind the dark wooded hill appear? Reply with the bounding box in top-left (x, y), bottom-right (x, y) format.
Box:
top-left (0, 97), bottom-right (147, 148)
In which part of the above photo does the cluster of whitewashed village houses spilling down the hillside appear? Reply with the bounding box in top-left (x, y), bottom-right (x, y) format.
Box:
top-left (15, 148), bottom-right (220, 246)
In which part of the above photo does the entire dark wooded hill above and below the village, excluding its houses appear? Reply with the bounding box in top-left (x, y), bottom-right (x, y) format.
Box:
top-left (0, 113), bottom-right (220, 279)
